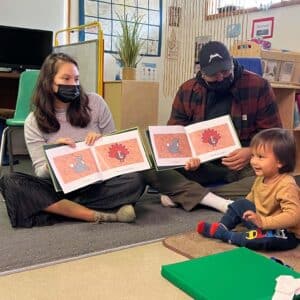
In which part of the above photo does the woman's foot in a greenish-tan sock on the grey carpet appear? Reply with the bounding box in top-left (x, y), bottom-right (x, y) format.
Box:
top-left (94, 204), bottom-right (136, 223)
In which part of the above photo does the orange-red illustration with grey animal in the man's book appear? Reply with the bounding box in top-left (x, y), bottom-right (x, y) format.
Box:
top-left (153, 133), bottom-right (192, 158)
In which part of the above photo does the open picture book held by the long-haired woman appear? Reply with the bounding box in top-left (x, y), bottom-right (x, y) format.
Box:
top-left (44, 128), bottom-right (151, 193)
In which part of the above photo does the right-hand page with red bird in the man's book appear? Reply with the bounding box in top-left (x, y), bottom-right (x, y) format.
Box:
top-left (185, 115), bottom-right (241, 162)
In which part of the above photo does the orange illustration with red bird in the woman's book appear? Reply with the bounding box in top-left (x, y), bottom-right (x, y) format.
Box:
top-left (95, 139), bottom-right (144, 171)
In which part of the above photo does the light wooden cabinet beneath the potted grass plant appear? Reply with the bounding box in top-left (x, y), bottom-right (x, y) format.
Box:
top-left (104, 80), bottom-right (159, 130)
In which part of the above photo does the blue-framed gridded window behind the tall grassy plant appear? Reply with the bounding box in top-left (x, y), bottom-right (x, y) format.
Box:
top-left (79, 0), bottom-right (162, 56)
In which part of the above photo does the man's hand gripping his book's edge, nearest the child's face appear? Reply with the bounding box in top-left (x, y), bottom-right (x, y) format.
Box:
top-left (222, 147), bottom-right (251, 171)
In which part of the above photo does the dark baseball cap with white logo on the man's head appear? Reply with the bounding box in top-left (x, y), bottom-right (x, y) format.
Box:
top-left (199, 41), bottom-right (233, 76)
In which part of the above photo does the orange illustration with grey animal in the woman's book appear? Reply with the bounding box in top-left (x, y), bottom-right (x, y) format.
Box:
top-left (53, 149), bottom-right (99, 184)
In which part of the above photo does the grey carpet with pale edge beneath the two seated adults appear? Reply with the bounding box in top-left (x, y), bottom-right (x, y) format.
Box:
top-left (0, 193), bottom-right (220, 275)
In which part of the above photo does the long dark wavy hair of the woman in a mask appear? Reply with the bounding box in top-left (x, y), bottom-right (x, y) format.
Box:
top-left (33, 53), bottom-right (91, 133)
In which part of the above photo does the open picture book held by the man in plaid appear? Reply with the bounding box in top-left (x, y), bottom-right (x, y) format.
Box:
top-left (146, 115), bottom-right (241, 170)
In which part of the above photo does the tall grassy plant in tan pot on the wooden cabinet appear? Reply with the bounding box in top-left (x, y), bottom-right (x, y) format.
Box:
top-left (116, 14), bottom-right (144, 80)
